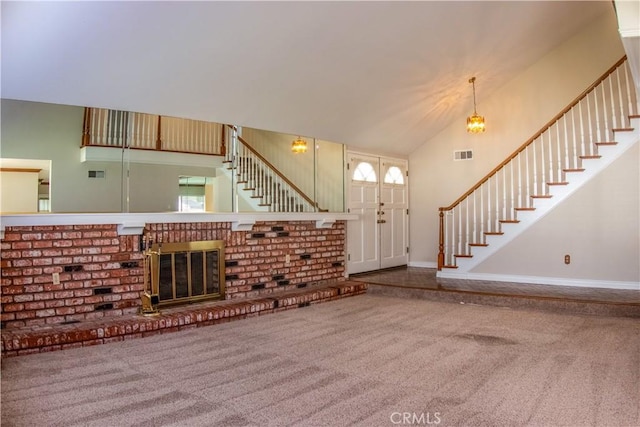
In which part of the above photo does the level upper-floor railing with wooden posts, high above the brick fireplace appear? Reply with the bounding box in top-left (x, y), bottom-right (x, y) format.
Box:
top-left (82, 107), bottom-right (226, 156)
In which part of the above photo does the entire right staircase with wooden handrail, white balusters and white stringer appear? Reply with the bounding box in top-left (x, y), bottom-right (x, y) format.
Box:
top-left (438, 57), bottom-right (640, 277)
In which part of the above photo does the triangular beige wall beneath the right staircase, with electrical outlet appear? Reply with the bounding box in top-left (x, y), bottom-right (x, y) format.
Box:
top-left (472, 144), bottom-right (640, 282)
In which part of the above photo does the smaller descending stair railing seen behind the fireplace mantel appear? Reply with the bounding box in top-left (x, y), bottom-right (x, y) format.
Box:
top-left (225, 125), bottom-right (320, 212)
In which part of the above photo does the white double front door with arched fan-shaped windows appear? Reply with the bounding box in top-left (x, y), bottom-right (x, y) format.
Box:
top-left (347, 153), bottom-right (409, 274)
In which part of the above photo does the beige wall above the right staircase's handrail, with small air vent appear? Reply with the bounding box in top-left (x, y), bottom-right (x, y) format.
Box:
top-left (409, 12), bottom-right (638, 275)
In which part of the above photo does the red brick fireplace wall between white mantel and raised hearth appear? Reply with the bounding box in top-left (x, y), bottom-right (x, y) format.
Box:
top-left (0, 221), bottom-right (345, 328)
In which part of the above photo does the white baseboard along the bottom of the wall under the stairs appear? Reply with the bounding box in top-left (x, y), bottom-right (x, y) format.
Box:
top-left (436, 270), bottom-right (640, 291)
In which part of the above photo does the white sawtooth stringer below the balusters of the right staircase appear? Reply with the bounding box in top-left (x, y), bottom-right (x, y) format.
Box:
top-left (437, 118), bottom-right (640, 279)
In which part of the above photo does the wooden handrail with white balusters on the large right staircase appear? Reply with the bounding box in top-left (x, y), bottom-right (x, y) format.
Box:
top-left (438, 56), bottom-right (639, 270)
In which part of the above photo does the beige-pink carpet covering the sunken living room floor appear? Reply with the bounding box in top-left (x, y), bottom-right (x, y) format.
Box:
top-left (2, 295), bottom-right (640, 427)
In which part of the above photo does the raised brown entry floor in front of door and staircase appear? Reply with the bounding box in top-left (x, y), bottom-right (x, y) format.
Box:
top-left (349, 267), bottom-right (640, 309)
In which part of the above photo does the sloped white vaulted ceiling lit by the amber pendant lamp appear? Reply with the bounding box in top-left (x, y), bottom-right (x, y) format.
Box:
top-left (1, 0), bottom-right (612, 156)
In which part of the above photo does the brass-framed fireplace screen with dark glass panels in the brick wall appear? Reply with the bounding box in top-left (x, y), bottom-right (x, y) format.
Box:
top-left (151, 240), bottom-right (224, 306)
